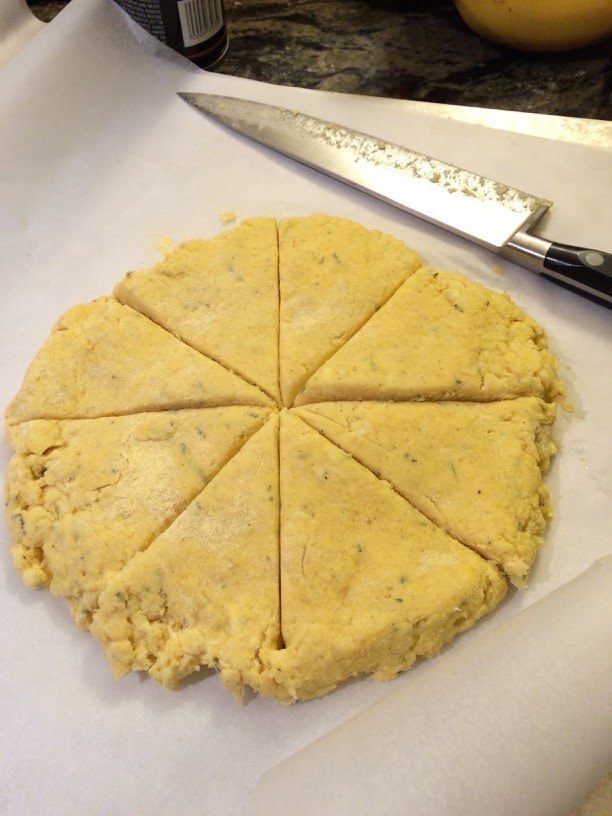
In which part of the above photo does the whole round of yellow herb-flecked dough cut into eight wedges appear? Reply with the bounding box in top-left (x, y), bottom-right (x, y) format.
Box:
top-left (6, 215), bottom-right (563, 702)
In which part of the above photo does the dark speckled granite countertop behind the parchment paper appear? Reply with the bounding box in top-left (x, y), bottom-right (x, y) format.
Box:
top-left (29, 0), bottom-right (612, 120)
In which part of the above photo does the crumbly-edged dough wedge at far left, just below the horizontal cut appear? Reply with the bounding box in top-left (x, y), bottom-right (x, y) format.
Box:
top-left (6, 407), bottom-right (269, 628)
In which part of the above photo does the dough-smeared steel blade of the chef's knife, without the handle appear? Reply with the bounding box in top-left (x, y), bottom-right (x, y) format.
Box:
top-left (180, 93), bottom-right (551, 251)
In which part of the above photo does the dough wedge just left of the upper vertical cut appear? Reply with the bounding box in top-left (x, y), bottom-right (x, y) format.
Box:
top-left (114, 218), bottom-right (280, 402)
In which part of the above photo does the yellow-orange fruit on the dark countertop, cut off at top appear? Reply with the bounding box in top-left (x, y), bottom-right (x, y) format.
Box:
top-left (455, 0), bottom-right (612, 51)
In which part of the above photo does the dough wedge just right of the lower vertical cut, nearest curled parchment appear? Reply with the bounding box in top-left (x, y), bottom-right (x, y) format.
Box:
top-left (270, 415), bottom-right (506, 699)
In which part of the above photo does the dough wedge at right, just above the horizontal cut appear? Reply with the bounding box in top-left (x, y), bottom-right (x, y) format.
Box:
top-left (295, 269), bottom-right (563, 405)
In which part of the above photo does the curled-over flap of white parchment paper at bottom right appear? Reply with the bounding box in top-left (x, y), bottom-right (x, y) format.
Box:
top-left (255, 556), bottom-right (612, 816)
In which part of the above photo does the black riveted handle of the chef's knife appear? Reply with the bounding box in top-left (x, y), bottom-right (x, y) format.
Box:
top-left (542, 243), bottom-right (612, 305)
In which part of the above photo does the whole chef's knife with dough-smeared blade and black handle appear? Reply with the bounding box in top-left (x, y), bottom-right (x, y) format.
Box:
top-left (179, 93), bottom-right (612, 304)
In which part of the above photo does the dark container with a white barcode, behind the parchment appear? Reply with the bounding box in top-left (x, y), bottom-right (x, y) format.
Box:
top-left (116, 0), bottom-right (228, 68)
